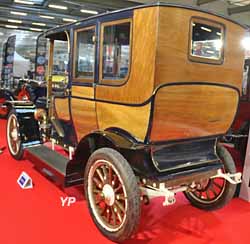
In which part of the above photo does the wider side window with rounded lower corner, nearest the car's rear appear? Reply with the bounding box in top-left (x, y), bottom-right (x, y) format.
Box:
top-left (100, 20), bottom-right (131, 85)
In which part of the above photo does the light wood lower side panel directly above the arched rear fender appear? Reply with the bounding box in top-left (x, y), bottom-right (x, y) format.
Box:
top-left (97, 102), bottom-right (150, 141)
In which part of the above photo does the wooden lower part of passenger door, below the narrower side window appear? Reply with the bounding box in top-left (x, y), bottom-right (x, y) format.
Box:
top-left (71, 86), bottom-right (98, 141)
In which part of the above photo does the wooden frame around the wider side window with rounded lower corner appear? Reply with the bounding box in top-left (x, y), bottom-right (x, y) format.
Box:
top-left (98, 18), bottom-right (133, 86)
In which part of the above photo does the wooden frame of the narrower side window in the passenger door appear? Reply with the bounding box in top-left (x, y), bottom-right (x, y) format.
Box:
top-left (72, 25), bottom-right (97, 83)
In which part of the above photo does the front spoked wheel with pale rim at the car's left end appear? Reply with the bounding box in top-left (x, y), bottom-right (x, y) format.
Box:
top-left (6, 110), bottom-right (24, 160)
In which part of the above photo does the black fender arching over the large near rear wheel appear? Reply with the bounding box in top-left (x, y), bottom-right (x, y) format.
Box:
top-left (66, 128), bottom-right (155, 179)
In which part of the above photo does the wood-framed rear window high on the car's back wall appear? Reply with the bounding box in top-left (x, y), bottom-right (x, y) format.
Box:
top-left (189, 18), bottom-right (224, 64)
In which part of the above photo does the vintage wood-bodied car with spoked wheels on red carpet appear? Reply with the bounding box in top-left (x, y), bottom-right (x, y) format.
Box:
top-left (7, 4), bottom-right (245, 242)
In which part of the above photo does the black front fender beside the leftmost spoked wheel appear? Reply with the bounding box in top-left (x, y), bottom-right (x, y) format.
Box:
top-left (9, 104), bottom-right (42, 148)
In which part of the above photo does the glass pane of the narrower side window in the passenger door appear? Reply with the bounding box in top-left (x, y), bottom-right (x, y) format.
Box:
top-left (75, 29), bottom-right (95, 78)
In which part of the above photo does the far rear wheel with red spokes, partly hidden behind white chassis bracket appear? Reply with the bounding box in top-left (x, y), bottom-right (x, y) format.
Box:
top-left (184, 145), bottom-right (236, 210)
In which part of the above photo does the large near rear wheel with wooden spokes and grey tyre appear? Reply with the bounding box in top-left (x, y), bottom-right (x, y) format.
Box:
top-left (84, 148), bottom-right (141, 242)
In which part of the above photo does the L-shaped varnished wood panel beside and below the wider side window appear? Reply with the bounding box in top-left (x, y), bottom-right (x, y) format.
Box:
top-left (96, 7), bottom-right (158, 103)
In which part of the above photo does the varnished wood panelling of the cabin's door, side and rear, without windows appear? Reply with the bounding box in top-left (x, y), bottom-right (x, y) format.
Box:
top-left (69, 7), bottom-right (244, 141)
